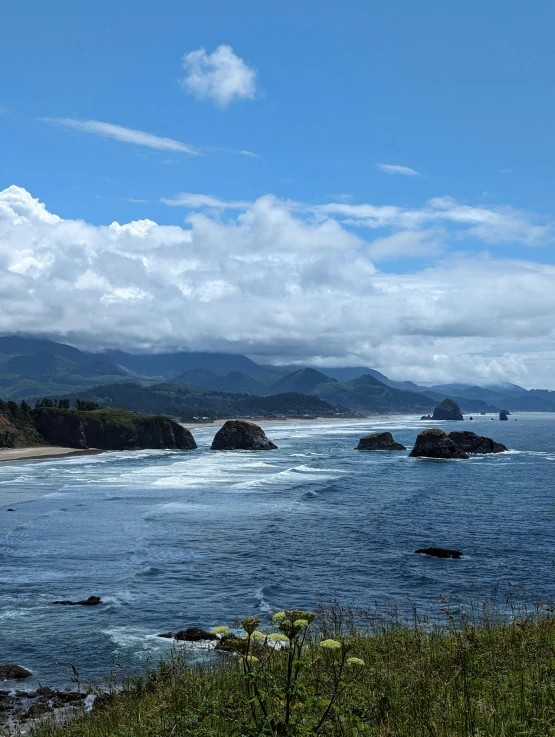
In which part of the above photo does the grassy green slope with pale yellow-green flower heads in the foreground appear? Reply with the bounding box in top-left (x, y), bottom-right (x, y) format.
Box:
top-left (28, 602), bottom-right (555, 737)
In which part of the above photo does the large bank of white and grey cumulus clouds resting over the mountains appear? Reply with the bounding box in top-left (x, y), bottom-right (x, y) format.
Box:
top-left (0, 186), bottom-right (555, 385)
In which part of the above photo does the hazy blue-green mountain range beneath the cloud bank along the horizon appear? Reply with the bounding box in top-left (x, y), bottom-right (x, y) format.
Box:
top-left (0, 336), bottom-right (555, 413)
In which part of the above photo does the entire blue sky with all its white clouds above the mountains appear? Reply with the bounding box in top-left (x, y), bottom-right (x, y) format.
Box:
top-left (0, 0), bottom-right (555, 389)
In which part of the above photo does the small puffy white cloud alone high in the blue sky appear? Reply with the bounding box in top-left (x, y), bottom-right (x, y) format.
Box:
top-left (181, 44), bottom-right (257, 108)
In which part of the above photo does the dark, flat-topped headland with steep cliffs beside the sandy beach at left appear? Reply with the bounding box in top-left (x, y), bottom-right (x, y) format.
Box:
top-left (33, 407), bottom-right (197, 450)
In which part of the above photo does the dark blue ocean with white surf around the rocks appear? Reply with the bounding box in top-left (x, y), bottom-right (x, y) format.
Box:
top-left (0, 414), bottom-right (555, 686)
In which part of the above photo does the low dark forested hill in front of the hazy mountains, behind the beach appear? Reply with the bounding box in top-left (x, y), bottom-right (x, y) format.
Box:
top-left (60, 383), bottom-right (357, 422)
